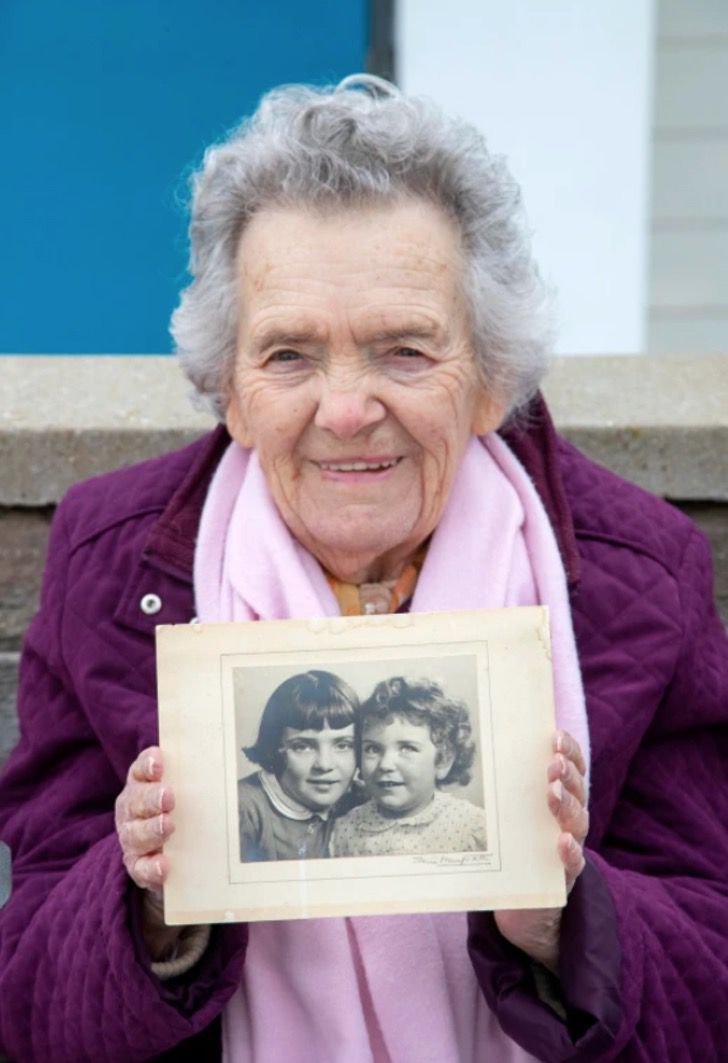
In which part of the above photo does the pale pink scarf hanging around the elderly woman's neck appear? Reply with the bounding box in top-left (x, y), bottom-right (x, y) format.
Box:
top-left (194, 434), bottom-right (589, 1063)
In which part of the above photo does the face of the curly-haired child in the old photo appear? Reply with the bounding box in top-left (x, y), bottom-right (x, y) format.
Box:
top-left (361, 716), bottom-right (453, 816)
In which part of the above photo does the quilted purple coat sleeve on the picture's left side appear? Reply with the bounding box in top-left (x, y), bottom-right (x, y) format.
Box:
top-left (0, 505), bottom-right (246, 1063)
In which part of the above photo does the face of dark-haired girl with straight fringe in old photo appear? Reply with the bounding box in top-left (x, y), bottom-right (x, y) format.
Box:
top-left (277, 724), bottom-right (356, 812)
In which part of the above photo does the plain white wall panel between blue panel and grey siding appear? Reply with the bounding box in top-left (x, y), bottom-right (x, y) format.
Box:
top-left (396, 0), bottom-right (655, 354)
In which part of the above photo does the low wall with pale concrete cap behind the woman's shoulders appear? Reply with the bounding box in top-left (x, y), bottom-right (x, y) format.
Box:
top-left (0, 355), bottom-right (728, 762)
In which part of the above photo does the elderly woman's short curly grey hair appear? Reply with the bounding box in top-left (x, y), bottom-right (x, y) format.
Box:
top-left (171, 74), bottom-right (553, 417)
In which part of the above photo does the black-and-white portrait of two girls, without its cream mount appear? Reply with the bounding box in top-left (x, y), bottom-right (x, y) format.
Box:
top-left (232, 654), bottom-right (492, 861)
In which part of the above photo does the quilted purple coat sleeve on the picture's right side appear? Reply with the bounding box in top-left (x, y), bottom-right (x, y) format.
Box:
top-left (470, 532), bottom-right (728, 1063)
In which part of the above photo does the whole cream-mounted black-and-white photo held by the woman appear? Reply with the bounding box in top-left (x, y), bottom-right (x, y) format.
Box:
top-left (157, 607), bottom-right (563, 923)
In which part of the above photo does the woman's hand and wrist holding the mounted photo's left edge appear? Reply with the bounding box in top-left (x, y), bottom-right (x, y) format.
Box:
top-left (115, 745), bottom-right (181, 960)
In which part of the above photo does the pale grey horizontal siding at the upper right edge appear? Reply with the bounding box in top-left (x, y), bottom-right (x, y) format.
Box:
top-left (648, 0), bottom-right (728, 354)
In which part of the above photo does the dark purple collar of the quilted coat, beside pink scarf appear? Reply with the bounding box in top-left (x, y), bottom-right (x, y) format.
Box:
top-left (145, 393), bottom-right (580, 589)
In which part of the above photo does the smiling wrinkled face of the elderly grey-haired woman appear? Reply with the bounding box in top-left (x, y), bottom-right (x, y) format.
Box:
top-left (226, 201), bottom-right (503, 583)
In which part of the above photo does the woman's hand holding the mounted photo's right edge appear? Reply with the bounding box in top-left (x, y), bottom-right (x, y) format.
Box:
top-left (494, 731), bottom-right (589, 973)
